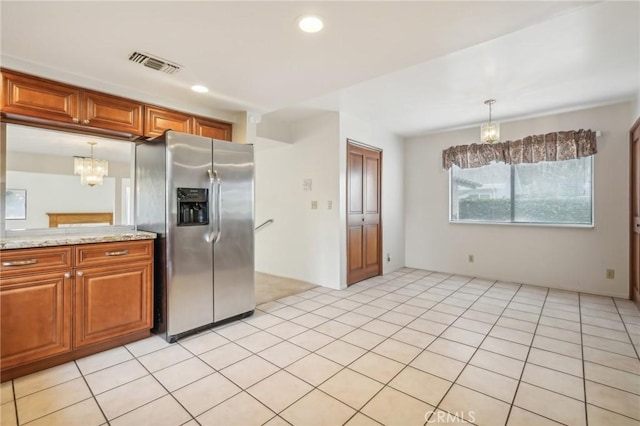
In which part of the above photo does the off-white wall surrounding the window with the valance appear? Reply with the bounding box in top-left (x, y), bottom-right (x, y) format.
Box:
top-left (405, 102), bottom-right (633, 298)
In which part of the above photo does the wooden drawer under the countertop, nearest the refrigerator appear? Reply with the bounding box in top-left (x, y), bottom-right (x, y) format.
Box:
top-left (75, 240), bottom-right (153, 268)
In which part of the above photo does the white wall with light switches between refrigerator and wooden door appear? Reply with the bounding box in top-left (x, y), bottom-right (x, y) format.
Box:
top-left (255, 113), bottom-right (340, 288)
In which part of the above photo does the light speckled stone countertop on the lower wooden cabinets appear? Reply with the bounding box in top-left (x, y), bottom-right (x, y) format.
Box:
top-left (0, 227), bottom-right (156, 250)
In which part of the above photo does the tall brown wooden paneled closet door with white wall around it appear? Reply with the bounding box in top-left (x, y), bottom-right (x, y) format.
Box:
top-left (347, 141), bottom-right (382, 285)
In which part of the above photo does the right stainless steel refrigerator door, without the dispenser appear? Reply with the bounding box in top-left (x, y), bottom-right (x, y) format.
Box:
top-left (213, 140), bottom-right (255, 322)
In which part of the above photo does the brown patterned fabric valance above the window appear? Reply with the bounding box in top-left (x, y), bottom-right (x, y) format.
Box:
top-left (442, 129), bottom-right (598, 170)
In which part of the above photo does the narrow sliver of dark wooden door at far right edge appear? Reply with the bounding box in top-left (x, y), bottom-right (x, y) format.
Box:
top-left (630, 118), bottom-right (640, 307)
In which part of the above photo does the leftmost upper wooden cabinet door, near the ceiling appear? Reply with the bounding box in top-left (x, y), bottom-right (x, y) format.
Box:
top-left (2, 71), bottom-right (80, 123)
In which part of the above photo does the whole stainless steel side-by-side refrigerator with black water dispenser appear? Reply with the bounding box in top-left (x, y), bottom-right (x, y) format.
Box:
top-left (135, 131), bottom-right (255, 342)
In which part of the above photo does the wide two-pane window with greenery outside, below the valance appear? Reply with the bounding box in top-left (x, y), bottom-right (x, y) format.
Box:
top-left (450, 157), bottom-right (593, 225)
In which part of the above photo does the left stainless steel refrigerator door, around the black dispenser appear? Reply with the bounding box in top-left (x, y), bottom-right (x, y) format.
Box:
top-left (166, 132), bottom-right (213, 336)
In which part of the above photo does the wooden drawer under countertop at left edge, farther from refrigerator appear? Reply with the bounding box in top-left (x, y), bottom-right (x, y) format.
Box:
top-left (0, 246), bottom-right (73, 285)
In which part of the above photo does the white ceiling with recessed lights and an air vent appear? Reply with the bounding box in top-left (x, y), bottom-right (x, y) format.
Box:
top-left (0, 1), bottom-right (640, 136)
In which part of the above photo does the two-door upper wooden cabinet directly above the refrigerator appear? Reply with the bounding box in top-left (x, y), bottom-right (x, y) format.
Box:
top-left (144, 105), bottom-right (232, 141)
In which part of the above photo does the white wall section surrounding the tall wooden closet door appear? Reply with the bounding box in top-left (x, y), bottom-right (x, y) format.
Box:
top-left (339, 113), bottom-right (405, 287)
